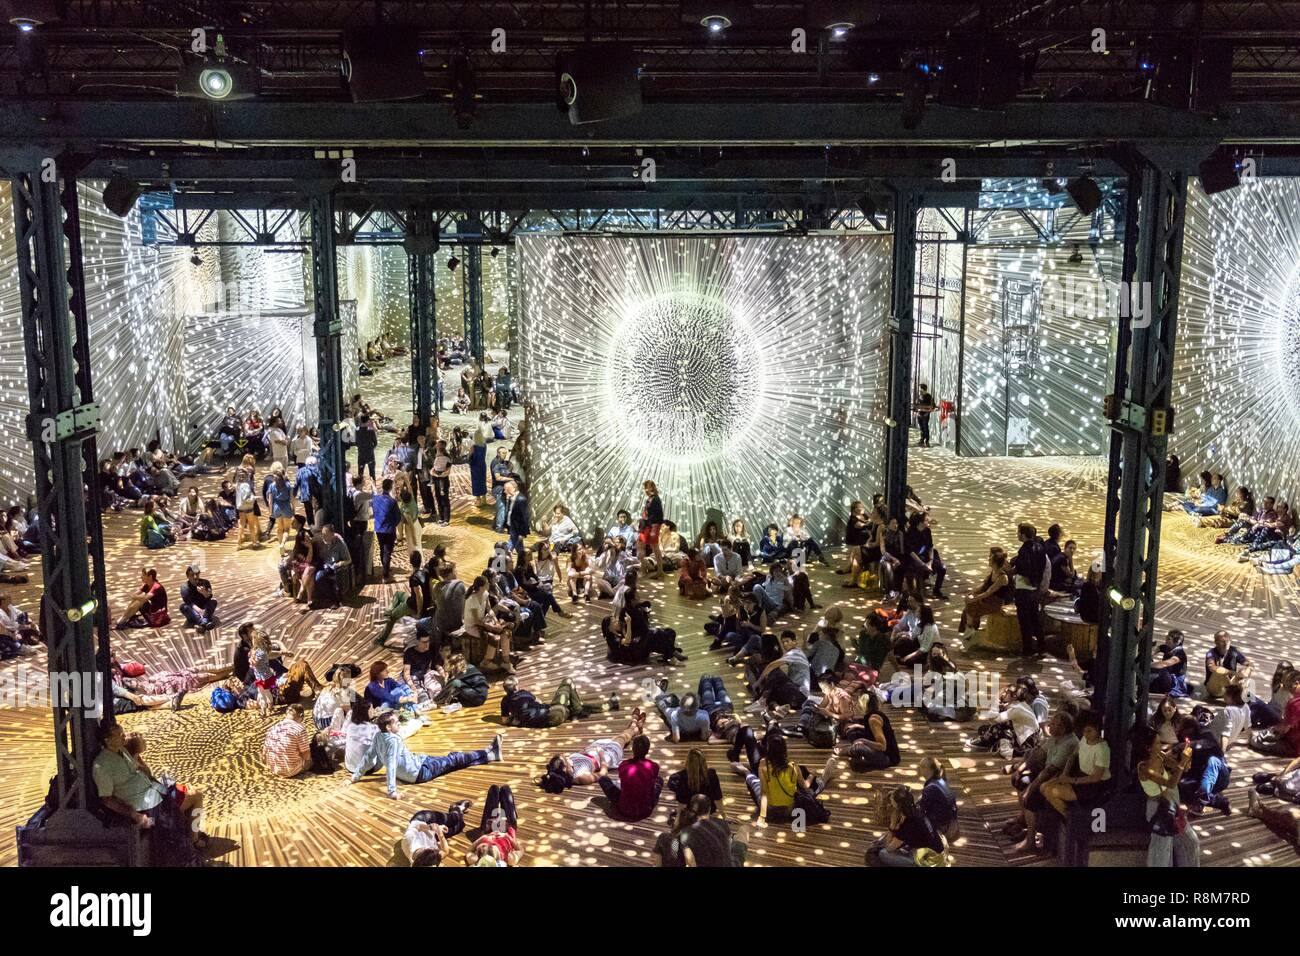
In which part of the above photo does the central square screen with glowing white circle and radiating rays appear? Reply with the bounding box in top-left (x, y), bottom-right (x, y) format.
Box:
top-left (516, 235), bottom-right (889, 537)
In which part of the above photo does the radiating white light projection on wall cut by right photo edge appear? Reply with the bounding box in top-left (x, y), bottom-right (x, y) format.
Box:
top-left (1170, 178), bottom-right (1300, 501)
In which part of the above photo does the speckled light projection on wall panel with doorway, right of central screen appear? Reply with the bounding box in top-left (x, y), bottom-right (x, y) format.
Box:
top-left (962, 214), bottom-right (1119, 455)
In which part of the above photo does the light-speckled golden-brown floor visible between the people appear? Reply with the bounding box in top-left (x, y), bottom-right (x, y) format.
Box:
top-left (0, 359), bottom-right (1300, 866)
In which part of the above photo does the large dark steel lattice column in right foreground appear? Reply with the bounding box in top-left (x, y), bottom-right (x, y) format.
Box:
top-left (1095, 155), bottom-right (1187, 778)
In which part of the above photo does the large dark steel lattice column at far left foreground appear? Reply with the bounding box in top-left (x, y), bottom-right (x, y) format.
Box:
top-left (10, 156), bottom-right (112, 832)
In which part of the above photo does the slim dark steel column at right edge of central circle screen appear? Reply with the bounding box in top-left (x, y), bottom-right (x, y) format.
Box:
top-left (885, 187), bottom-right (920, 523)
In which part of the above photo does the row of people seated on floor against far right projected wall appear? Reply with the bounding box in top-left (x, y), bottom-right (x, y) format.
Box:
top-left (1165, 471), bottom-right (1300, 575)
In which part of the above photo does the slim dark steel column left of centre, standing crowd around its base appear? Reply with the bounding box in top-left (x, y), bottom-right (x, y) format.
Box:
top-left (311, 191), bottom-right (347, 533)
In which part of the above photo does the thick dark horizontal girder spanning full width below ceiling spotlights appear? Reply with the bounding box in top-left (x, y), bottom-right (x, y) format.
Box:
top-left (0, 100), bottom-right (1300, 150)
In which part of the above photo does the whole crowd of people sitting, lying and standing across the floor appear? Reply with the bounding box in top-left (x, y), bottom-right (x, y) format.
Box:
top-left (10, 369), bottom-right (1300, 866)
